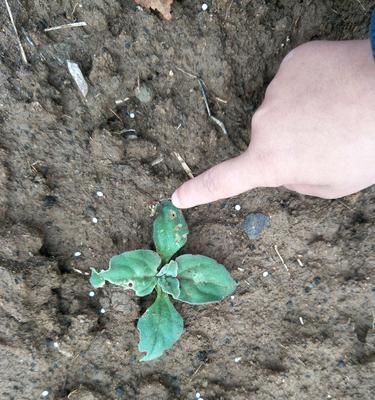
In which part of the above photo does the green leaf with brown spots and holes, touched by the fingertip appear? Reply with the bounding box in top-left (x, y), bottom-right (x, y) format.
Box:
top-left (153, 200), bottom-right (189, 263)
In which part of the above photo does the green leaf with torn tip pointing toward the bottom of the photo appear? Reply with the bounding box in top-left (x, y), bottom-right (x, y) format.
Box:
top-left (137, 287), bottom-right (184, 361)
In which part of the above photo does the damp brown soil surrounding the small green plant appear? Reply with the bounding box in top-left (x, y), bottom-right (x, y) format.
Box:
top-left (0, 0), bottom-right (375, 400)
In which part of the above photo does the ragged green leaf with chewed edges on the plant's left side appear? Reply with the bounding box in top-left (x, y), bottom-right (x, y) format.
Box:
top-left (90, 250), bottom-right (161, 296)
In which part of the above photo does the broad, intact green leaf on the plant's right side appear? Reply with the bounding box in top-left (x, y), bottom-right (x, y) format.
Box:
top-left (174, 254), bottom-right (237, 304)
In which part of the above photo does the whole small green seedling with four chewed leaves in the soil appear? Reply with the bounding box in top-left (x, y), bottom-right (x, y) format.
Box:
top-left (90, 200), bottom-right (236, 361)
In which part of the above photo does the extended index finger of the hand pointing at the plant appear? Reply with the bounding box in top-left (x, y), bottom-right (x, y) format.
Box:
top-left (172, 151), bottom-right (268, 208)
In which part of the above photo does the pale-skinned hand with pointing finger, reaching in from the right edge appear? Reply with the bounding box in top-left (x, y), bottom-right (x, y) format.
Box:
top-left (172, 40), bottom-right (375, 208)
